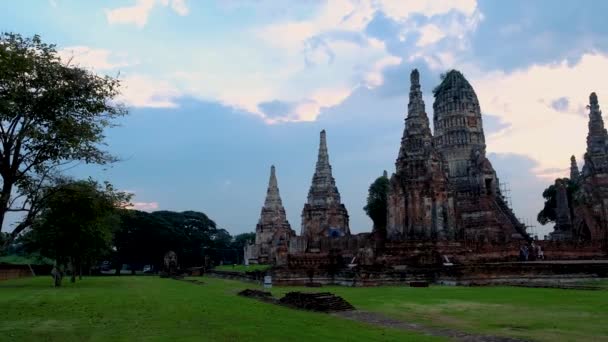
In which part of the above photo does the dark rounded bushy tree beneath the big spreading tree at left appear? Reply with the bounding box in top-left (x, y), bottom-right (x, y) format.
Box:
top-left (24, 179), bottom-right (130, 282)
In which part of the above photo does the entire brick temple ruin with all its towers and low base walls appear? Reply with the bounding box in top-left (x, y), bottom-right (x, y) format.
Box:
top-left (245, 70), bottom-right (608, 284)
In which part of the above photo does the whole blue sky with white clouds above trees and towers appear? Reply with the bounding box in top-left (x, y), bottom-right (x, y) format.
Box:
top-left (0, 0), bottom-right (608, 236)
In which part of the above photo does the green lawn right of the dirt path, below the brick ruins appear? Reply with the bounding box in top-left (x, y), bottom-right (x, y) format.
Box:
top-left (272, 280), bottom-right (608, 341)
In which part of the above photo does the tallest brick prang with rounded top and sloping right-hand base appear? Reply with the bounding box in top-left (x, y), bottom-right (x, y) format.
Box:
top-left (433, 70), bottom-right (529, 243)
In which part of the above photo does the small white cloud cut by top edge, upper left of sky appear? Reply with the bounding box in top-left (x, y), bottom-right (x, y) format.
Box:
top-left (106, 0), bottom-right (189, 28)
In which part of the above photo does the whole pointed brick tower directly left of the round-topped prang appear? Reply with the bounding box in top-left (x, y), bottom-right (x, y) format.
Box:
top-left (387, 69), bottom-right (454, 240)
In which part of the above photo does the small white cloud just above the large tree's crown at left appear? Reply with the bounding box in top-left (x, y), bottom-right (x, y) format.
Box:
top-left (58, 46), bottom-right (137, 71)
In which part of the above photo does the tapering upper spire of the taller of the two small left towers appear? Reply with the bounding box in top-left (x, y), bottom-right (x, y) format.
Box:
top-left (308, 130), bottom-right (340, 205)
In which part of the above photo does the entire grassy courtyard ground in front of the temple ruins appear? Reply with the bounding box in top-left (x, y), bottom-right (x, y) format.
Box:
top-left (0, 276), bottom-right (608, 341)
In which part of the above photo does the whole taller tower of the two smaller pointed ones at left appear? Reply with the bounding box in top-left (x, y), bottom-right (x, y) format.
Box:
top-left (301, 130), bottom-right (350, 241)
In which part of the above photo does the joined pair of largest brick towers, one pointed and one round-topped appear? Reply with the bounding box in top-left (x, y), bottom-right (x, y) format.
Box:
top-left (388, 70), bottom-right (529, 243)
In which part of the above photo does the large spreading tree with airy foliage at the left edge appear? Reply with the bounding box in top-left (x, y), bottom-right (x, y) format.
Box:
top-left (0, 33), bottom-right (127, 246)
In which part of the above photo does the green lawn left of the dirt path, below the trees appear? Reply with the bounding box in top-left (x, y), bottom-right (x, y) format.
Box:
top-left (0, 276), bottom-right (439, 341)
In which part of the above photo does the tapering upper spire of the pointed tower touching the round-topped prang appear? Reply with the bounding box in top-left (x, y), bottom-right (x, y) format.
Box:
top-left (397, 69), bottom-right (433, 171)
